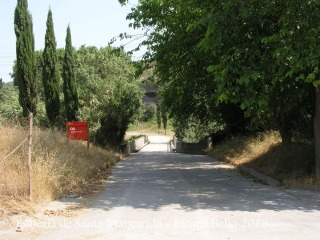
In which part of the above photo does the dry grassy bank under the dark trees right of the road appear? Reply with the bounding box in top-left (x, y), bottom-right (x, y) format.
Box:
top-left (209, 132), bottom-right (319, 184)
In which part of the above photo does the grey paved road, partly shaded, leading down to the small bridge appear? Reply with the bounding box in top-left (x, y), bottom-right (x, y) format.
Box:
top-left (2, 136), bottom-right (320, 240)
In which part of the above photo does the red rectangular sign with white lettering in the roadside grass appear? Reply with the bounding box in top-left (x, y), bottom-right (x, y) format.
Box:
top-left (67, 122), bottom-right (89, 141)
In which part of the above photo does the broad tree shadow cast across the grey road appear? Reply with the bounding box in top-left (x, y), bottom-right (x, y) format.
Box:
top-left (90, 149), bottom-right (320, 212)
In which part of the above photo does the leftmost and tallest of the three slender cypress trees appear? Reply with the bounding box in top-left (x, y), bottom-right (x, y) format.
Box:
top-left (14, 0), bottom-right (37, 117)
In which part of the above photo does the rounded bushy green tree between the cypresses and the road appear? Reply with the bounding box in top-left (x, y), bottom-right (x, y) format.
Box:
top-left (75, 46), bottom-right (142, 148)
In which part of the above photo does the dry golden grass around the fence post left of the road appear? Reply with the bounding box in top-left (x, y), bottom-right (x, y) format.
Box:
top-left (0, 125), bottom-right (122, 216)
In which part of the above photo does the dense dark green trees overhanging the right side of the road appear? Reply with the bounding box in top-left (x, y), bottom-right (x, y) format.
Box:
top-left (119, 0), bottom-right (320, 179)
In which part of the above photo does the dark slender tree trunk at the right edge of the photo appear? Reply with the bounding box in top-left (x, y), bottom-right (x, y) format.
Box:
top-left (313, 86), bottom-right (320, 180)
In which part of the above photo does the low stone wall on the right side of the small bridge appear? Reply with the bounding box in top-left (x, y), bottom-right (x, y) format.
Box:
top-left (171, 136), bottom-right (212, 155)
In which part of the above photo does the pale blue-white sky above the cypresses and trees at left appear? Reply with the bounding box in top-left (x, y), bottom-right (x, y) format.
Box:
top-left (0, 0), bottom-right (141, 82)
